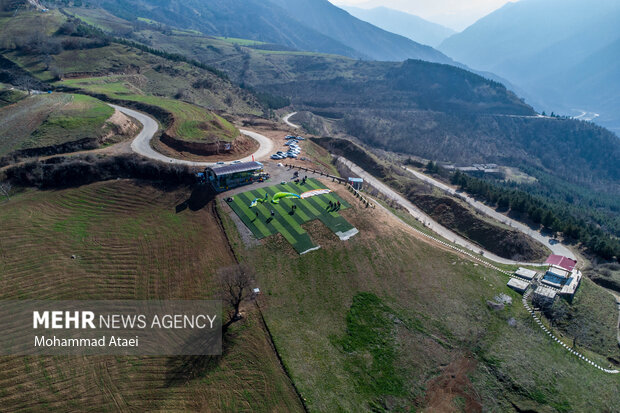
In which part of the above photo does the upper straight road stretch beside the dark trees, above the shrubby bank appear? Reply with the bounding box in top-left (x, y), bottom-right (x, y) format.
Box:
top-left (405, 168), bottom-right (576, 259)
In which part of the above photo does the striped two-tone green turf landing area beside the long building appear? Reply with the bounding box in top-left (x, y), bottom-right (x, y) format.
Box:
top-left (229, 179), bottom-right (353, 254)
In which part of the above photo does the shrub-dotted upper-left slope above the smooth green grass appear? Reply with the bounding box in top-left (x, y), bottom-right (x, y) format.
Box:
top-left (0, 10), bottom-right (262, 114)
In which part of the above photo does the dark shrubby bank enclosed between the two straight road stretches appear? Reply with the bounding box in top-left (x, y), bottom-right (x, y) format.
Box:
top-left (408, 193), bottom-right (547, 262)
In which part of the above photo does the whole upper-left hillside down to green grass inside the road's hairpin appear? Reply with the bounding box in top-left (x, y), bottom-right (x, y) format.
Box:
top-left (0, 11), bottom-right (252, 142)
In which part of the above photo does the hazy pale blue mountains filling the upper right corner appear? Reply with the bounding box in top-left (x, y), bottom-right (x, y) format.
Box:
top-left (439, 0), bottom-right (620, 134)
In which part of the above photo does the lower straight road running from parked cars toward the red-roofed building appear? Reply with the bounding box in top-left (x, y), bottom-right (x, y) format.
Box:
top-left (338, 156), bottom-right (542, 266)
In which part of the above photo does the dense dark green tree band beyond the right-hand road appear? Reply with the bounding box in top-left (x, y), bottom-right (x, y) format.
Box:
top-left (451, 171), bottom-right (620, 260)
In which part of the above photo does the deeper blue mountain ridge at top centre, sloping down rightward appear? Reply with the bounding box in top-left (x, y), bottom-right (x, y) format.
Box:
top-left (94, 0), bottom-right (452, 63)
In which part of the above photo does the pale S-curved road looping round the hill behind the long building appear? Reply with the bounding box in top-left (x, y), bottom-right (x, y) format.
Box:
top-left (110, 105), bottom-right (273, 167)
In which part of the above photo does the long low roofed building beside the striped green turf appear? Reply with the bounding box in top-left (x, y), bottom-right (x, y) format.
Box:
top-left (205, 161), bottom-right (264, 192)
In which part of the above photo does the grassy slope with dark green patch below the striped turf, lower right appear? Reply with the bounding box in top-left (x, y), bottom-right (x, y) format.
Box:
top-left (227, 185), bottom-right (620, 412)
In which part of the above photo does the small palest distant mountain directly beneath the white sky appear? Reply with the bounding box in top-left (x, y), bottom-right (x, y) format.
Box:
top-left (341, 6), bottom-right (456, 47)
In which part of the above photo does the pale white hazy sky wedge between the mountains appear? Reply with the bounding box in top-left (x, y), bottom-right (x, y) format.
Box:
top-left (330, 0), bottom-right (515, 31)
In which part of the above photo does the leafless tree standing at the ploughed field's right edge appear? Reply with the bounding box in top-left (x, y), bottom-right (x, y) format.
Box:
top-left (218, 264), bottom-right (254, 330)
